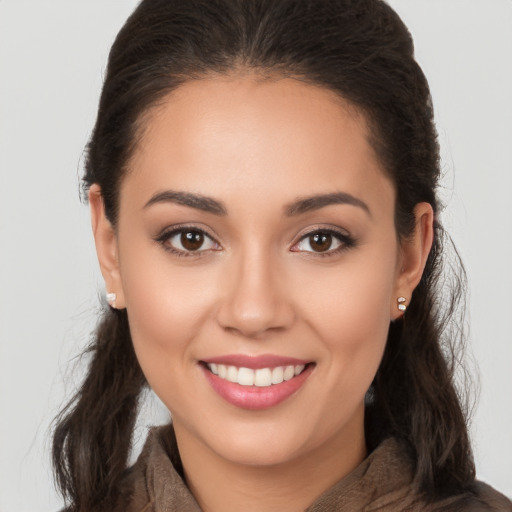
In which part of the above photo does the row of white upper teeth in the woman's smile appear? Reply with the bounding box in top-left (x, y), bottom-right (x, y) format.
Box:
top-left (207, 363), bottom-right (306, 388)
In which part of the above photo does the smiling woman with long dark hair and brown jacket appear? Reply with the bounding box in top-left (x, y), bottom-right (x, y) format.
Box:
top-left (53, 0), bottom-right (512, 511)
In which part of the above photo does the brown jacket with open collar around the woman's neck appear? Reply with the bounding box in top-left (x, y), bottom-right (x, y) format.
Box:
top-left (119, 425), bottom-right (512, 512)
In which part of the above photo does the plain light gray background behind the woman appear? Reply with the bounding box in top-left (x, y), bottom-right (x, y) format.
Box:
top-left (0, 0), bottom-right (512, 512)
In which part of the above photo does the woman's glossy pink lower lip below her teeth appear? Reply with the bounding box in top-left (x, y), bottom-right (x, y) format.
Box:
top-left (201, 364), bottom-right (314, 410)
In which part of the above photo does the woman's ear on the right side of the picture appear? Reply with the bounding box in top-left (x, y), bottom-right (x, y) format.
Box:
top-left (391, 203), bottom-right (434, 319)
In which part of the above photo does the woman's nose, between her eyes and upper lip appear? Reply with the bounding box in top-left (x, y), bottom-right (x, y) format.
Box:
top-left (217, 250), bottom-right (295, 338)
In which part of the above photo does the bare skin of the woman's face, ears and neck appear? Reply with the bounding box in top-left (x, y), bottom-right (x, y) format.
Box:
top-left (90, 75), bottom-right (433, 512)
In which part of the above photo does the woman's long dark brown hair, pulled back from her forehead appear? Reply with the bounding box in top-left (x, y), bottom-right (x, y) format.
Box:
top-left (53, 0), bottom-right (475, 512)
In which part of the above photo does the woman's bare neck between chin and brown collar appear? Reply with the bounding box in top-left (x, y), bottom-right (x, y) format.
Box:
top-left (175, 425), bottom-right (366, 512)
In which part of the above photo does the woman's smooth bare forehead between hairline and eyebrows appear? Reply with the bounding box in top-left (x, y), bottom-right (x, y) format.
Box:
top-left (121, 76), bottom-right (393, 213)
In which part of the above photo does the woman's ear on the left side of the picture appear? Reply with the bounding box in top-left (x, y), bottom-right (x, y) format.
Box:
top-left (89, 184), bottom-right (125, 309)
